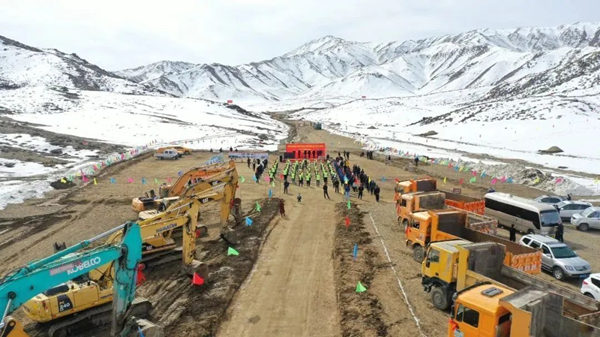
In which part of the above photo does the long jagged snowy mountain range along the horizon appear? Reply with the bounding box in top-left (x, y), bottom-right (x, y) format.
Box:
top-left (117, 23), bottom-right (600, 101)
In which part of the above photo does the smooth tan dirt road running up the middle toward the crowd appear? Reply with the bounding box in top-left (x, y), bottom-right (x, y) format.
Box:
top-left (218, 176), bottom-right (341, 336)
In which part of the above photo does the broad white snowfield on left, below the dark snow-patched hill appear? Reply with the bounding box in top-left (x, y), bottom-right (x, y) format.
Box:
top-left (0, 91), bottom-right (287, 150)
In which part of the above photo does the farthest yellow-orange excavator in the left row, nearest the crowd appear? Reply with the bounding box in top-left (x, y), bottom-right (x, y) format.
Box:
top-left (131, 160), bottom-right (238, 212)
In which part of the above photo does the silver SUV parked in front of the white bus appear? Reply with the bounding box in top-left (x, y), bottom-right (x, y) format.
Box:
top-left (519, 234), bottom-right (592, 280)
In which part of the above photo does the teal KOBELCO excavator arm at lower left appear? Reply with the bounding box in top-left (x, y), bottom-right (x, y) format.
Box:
top-left (0, 223), bottom-right (142, 337)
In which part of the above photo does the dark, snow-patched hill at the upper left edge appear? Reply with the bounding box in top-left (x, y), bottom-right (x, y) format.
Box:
top-left (0, 36), bottom-right (156, 94)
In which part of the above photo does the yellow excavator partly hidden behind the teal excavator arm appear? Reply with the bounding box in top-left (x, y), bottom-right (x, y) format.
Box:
top-left (24, 183), bottom-right (235, 332)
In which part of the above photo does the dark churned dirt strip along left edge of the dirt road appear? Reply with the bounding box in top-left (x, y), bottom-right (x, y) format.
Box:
top-left (138, 198), bottom-right (279, 336)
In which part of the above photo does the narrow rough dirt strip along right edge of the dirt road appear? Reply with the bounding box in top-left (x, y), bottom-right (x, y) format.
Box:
top-left (333, 203), bottom-right (388, 336)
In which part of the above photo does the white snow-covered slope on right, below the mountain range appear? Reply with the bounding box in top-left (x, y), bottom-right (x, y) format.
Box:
top-left (282, 91), bottom-right (600, 195)
